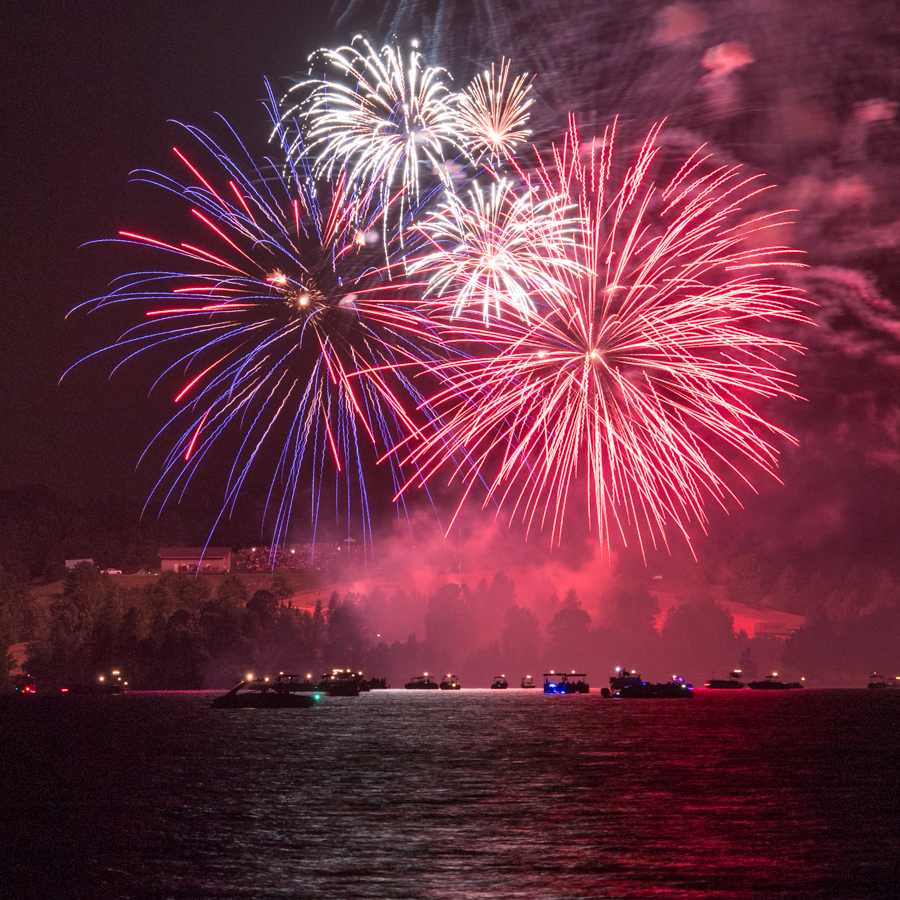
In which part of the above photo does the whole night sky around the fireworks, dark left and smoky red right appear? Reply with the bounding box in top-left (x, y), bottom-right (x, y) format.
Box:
top-left (0, 0), bottom-right (900, 564)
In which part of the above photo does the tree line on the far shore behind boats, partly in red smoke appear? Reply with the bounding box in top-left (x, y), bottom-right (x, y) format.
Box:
top-left (0, 564), bottom-right (900, 690)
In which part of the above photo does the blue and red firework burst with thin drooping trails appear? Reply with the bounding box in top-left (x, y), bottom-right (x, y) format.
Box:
top-left (68, 96), bottom-right (448, 543)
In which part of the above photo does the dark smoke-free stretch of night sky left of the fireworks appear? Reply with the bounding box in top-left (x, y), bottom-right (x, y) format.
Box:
top-left (0, 0), bottom-right (329, 496)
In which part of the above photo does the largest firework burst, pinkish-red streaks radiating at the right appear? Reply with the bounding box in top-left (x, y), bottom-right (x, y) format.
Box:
top-left (395, 119), bottom-right (805, 548)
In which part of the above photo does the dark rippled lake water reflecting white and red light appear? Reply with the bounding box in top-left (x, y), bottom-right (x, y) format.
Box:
top-left (0, 689), bottom-right (900, 900)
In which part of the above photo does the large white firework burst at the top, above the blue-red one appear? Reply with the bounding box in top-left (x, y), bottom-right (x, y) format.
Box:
top-left (282, 37), bottom-right (471, 242)
